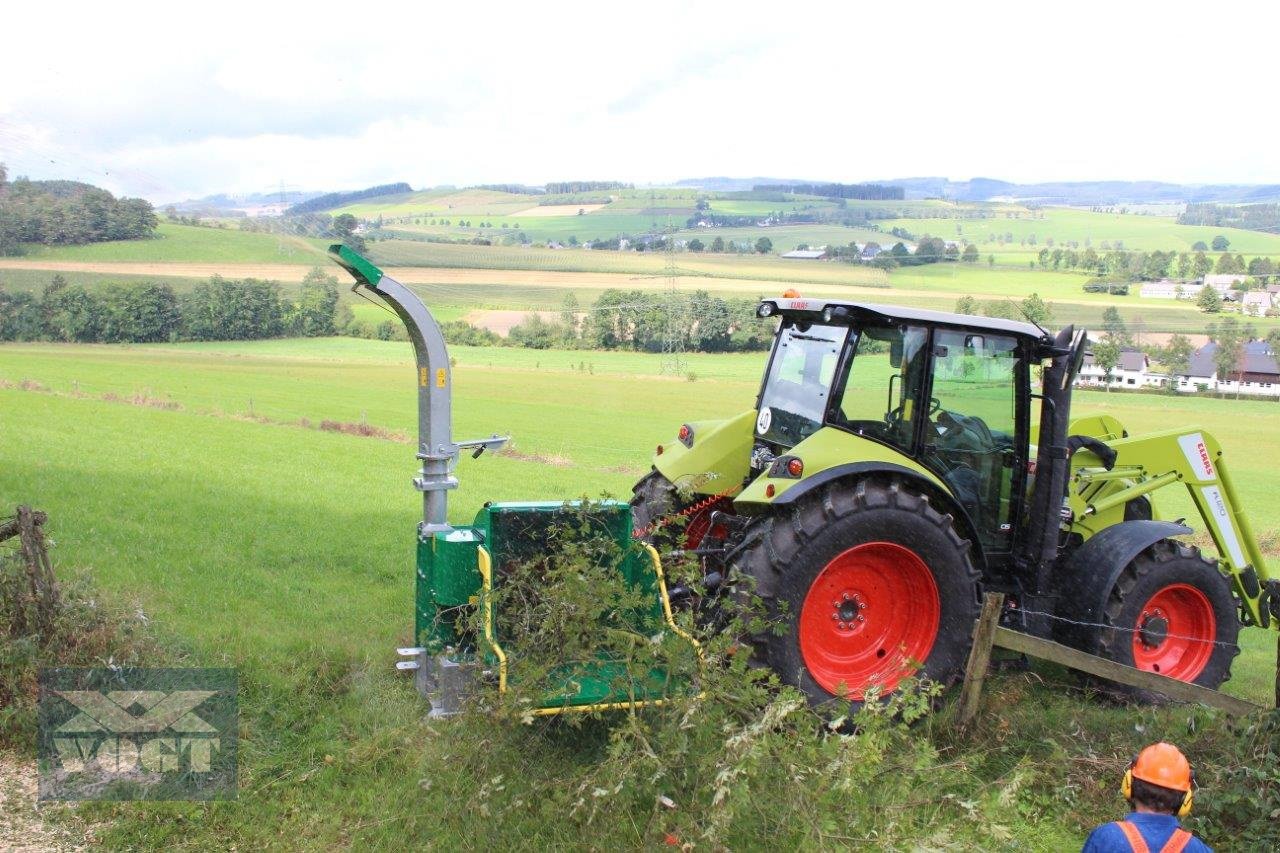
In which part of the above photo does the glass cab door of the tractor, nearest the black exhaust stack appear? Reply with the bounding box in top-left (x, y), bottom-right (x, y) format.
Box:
top-left (922, 329), bottom-right (1025, 553)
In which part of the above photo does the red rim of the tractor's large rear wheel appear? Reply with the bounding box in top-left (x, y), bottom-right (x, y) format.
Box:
top-left (799, 542), bottom-right (942, 699)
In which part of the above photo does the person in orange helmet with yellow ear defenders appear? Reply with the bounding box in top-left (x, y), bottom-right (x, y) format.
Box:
top-left (1080, 742), bottom-right (1212, 853)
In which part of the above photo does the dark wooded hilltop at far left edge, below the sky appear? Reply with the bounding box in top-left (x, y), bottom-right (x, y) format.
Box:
top-left (0, 164), bottom-right (157, 255)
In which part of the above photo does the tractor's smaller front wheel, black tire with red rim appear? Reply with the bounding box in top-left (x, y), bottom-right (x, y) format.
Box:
top-left (1094, 539), bottom-right (1240, 703)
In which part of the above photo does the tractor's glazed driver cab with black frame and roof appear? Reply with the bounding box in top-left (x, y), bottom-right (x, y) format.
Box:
top-left (748, 298), bottom-right (1046, 553)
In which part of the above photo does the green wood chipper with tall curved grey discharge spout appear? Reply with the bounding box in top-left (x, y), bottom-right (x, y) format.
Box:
top-left (329, 245), bottom-right (696, 716)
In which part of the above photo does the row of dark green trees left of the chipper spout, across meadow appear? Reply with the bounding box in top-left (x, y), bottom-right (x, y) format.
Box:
top-left (0, 269), bottom-right (351, 343)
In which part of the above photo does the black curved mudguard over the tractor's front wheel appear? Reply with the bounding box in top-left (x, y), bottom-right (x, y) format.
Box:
top-left (1053, 520), bottom-right (1192, 652)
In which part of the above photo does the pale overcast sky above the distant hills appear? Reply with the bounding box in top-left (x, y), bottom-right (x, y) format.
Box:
top-left (0, 0), bottom-right (1280, 201)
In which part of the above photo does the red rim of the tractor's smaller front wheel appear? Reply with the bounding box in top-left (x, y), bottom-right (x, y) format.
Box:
top-left (1133, 584), bottom-right (1217, 681)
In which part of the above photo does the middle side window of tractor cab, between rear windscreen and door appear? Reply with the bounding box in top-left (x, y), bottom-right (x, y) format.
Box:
top-left (837, 325), bottom-right (928, 452)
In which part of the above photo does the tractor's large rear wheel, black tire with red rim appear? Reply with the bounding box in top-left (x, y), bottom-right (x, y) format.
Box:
top-left (730, 479), bottom-right (979, 706)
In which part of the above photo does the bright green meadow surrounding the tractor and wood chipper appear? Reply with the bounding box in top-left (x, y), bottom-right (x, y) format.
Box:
top-left (0, 338), bottom-right (1280, 849)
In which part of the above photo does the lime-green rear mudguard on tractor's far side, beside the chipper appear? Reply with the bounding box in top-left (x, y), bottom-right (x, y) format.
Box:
top-left (653, 409), bottom-right (755, 494)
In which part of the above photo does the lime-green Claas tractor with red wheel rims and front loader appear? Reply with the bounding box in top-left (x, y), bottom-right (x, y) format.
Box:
top-left (632, 297), bottom-right (1280, 703)
